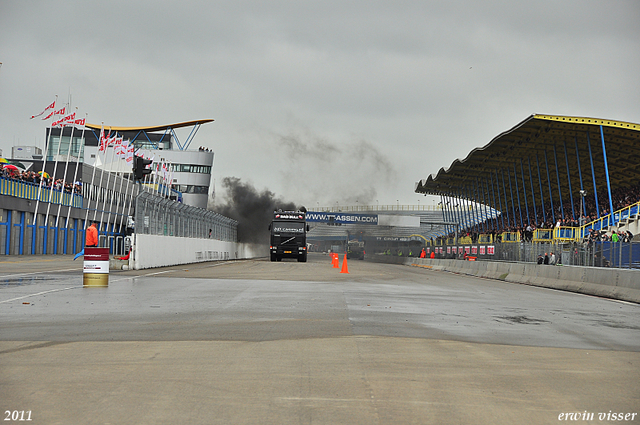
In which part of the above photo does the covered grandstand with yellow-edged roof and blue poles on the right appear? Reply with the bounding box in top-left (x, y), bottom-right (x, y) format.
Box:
top-left (415, 115), bottom-right (640, 263)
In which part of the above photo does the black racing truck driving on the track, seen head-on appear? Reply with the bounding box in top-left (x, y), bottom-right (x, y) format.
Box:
top-left (269, 211), bottom-right (309, 263)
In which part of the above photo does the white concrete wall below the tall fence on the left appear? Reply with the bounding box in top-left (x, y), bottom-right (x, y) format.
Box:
top-left (129, 235), bottom-right (268, 270)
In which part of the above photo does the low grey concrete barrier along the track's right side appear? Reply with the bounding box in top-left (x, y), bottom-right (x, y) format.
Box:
top-left (404, 258), bottom-right (640, 303)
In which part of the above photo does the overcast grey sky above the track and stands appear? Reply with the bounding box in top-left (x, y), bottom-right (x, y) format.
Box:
top-left (0, 0), bottom-right (640, 208)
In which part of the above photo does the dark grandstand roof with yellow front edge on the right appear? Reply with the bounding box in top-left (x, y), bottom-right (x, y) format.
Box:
top-left (415, 114), bottom-right (640, 208)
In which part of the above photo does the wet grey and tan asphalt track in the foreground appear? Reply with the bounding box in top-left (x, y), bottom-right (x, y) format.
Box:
top-left (0, 254), bottom-right (640, 423)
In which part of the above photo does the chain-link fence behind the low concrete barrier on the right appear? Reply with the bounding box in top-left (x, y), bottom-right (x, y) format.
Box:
top-left (434, 241), bottom-right (640, 268)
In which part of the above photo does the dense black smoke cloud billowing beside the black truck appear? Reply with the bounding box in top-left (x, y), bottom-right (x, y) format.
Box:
top-left (212, 177), bottom-right (298, 244)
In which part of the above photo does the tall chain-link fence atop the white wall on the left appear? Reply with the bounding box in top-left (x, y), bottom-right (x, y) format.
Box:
top-left (134, 192), bottom-right (238, 242)
